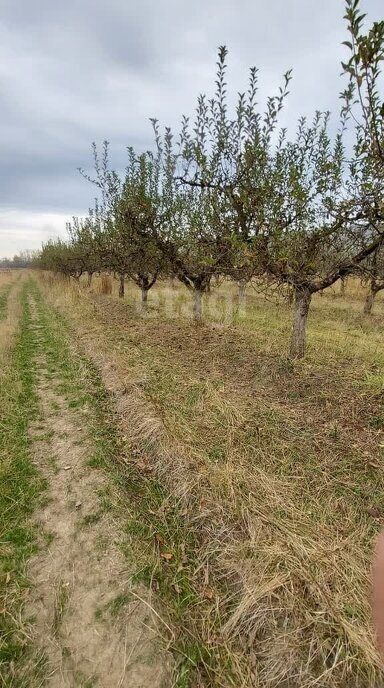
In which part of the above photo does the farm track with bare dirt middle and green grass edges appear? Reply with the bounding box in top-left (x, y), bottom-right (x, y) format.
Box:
top-left (0, 275), bottom-right (172, 688)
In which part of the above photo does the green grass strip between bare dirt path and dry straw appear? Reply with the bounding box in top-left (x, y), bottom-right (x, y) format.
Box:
top-left (33, 276), bottom-right (225, 688)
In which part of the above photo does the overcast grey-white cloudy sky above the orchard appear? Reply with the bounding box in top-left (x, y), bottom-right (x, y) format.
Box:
top-left (0, 0), bottom-right (384, 256)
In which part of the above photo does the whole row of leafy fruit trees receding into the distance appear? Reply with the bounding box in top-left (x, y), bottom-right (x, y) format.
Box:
top-left (41, 0), bottom-right (384, 358)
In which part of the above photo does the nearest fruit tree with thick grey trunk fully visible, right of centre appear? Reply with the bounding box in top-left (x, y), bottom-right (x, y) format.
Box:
top-left (256, 113), bottom-right (382, 358)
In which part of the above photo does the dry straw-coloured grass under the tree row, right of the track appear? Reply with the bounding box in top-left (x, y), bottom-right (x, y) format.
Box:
top-left (40, 270), bottom-right (384, 688)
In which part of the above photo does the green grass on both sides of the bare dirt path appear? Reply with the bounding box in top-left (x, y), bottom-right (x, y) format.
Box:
top-left (0, 280), bottom-right (201, 688)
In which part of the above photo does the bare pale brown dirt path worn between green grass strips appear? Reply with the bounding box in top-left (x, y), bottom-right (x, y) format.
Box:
top-left (26, 297), bottom-right (172, 688)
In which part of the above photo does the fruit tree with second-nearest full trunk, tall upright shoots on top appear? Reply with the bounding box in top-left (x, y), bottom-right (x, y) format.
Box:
top-left (153, 51), bottom-right (290, 320)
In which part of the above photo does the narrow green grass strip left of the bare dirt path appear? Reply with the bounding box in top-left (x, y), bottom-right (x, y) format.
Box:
top-left (0, 285), bottom-right (44, 688)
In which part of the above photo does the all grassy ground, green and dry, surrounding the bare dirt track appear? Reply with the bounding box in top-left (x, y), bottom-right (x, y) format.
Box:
top-left (0, 275), bottom-right (384, 688)
